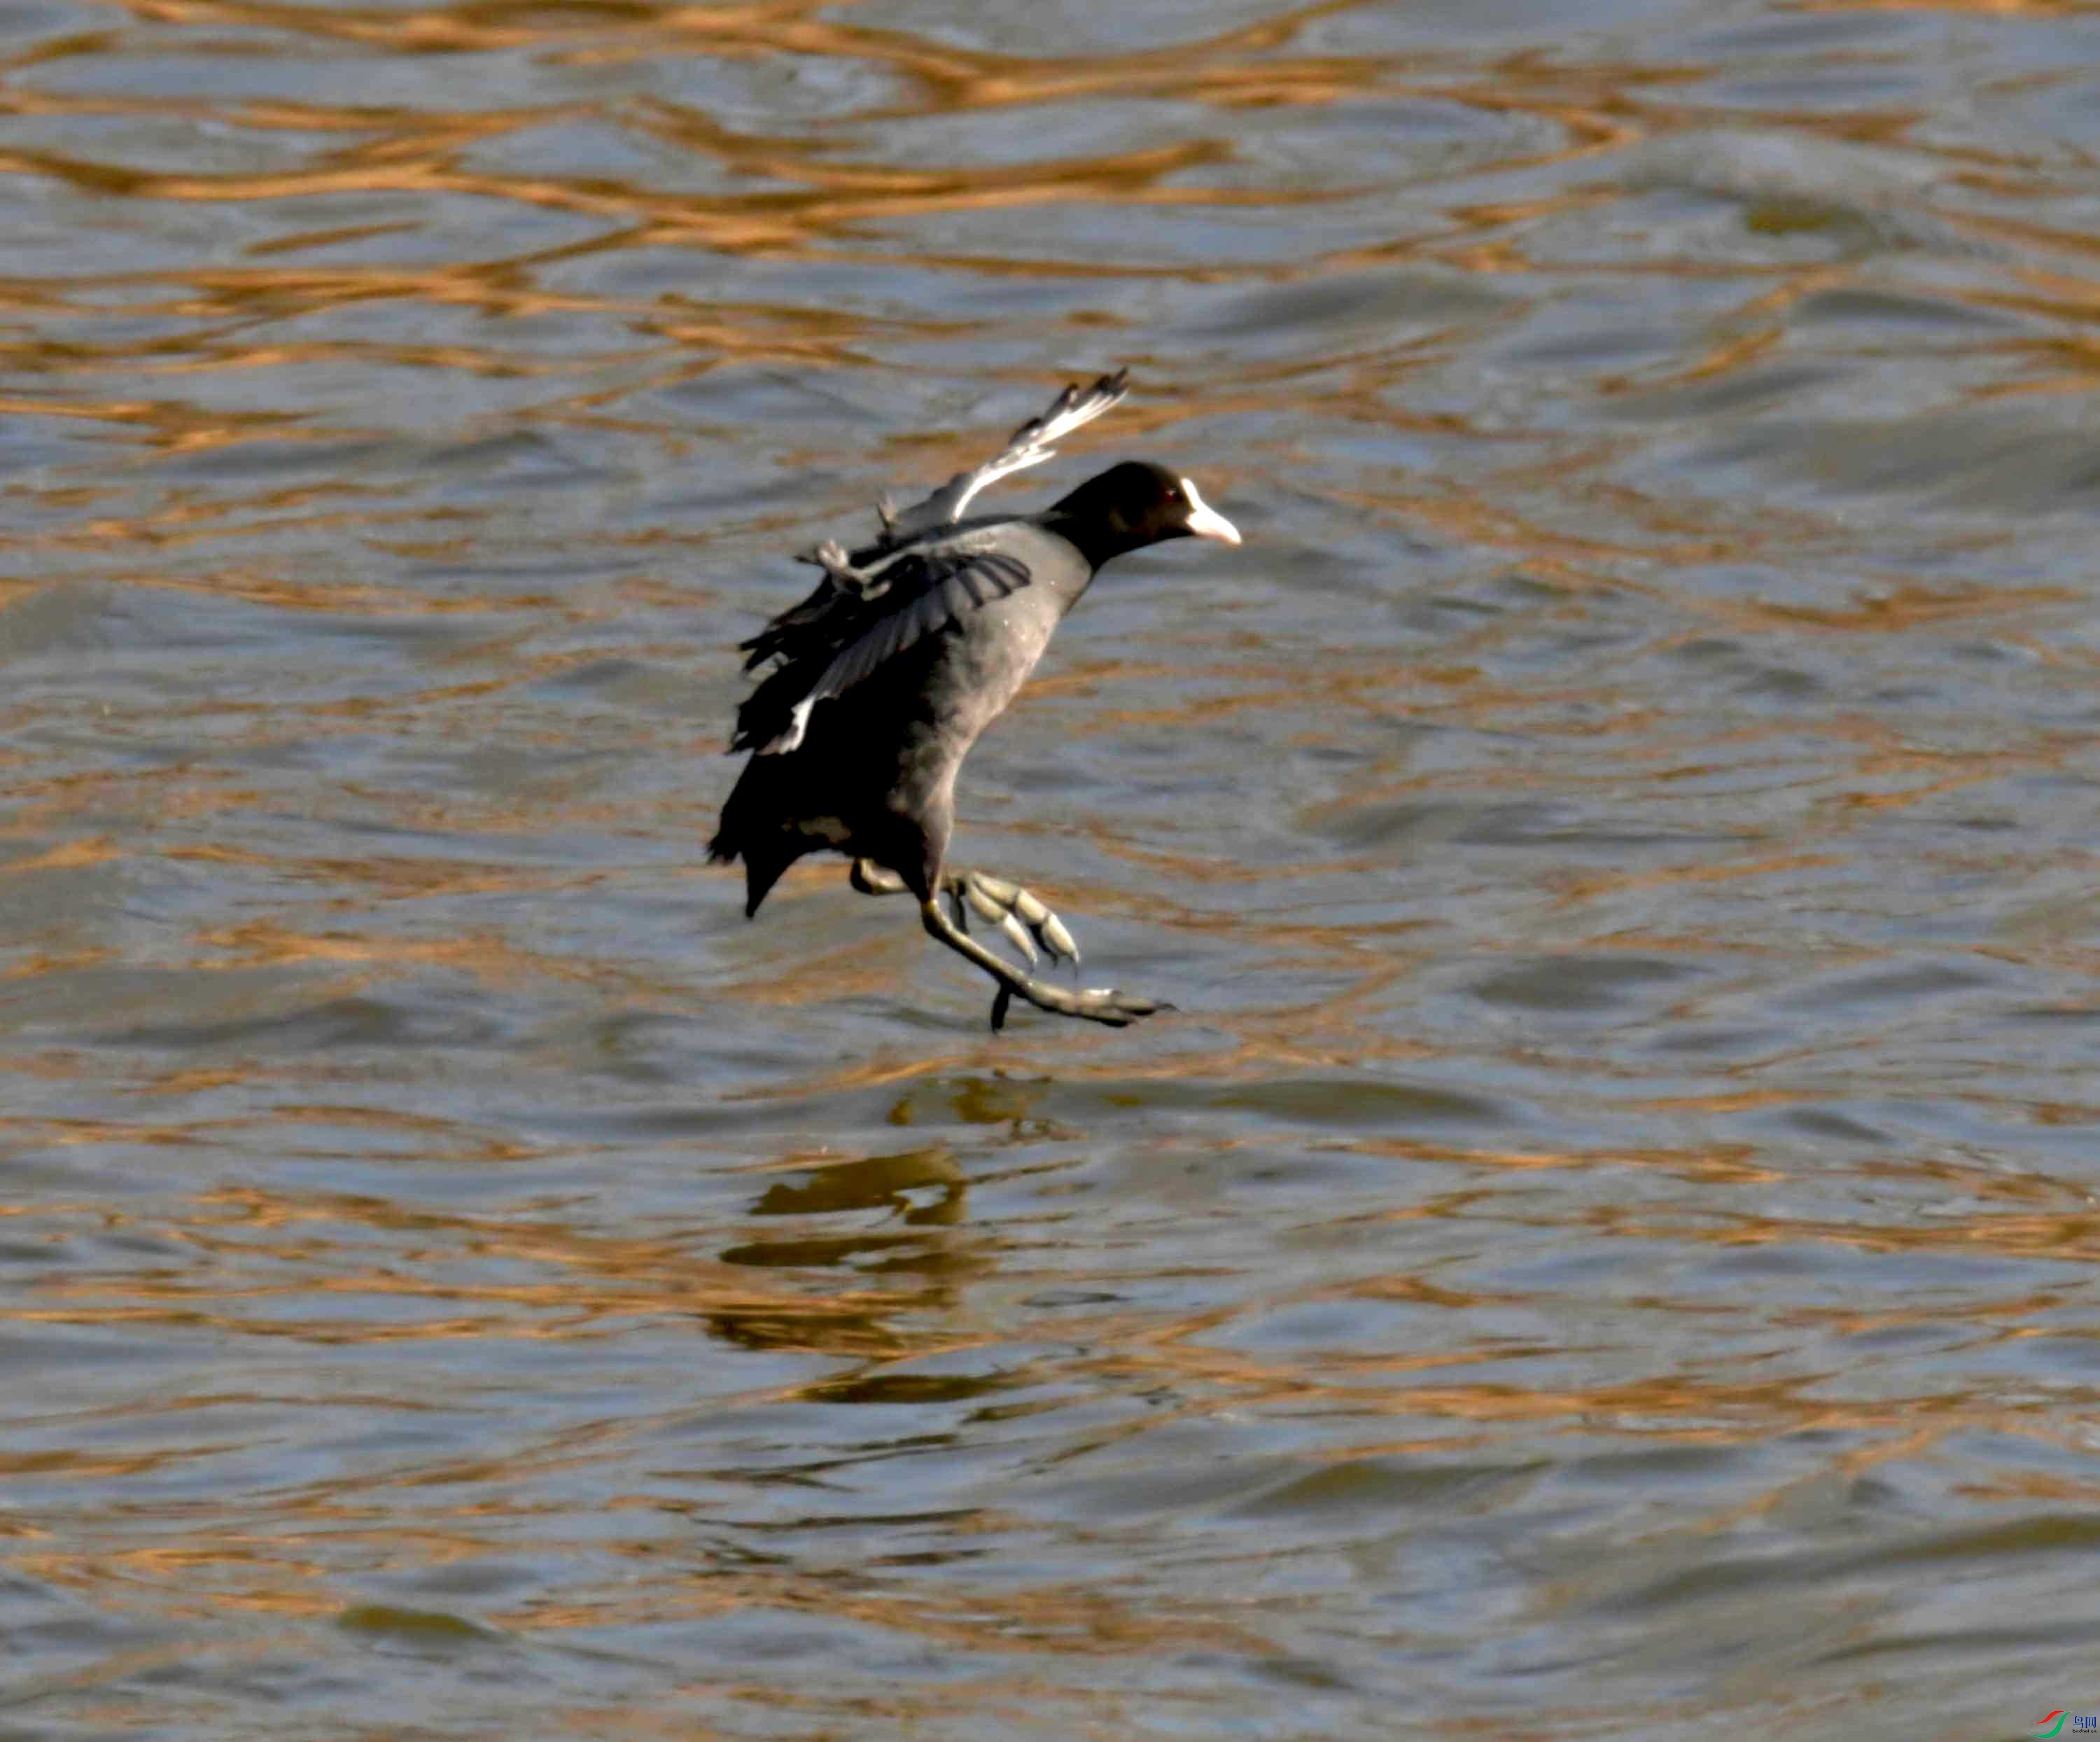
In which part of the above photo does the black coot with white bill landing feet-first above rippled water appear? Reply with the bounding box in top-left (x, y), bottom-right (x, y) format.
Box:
top-left (708, 372), bottom-right (1239, 1028)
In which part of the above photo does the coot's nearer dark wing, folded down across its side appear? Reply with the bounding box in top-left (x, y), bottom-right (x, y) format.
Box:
top-left (729, 531), bottom-right (1029, 756)
